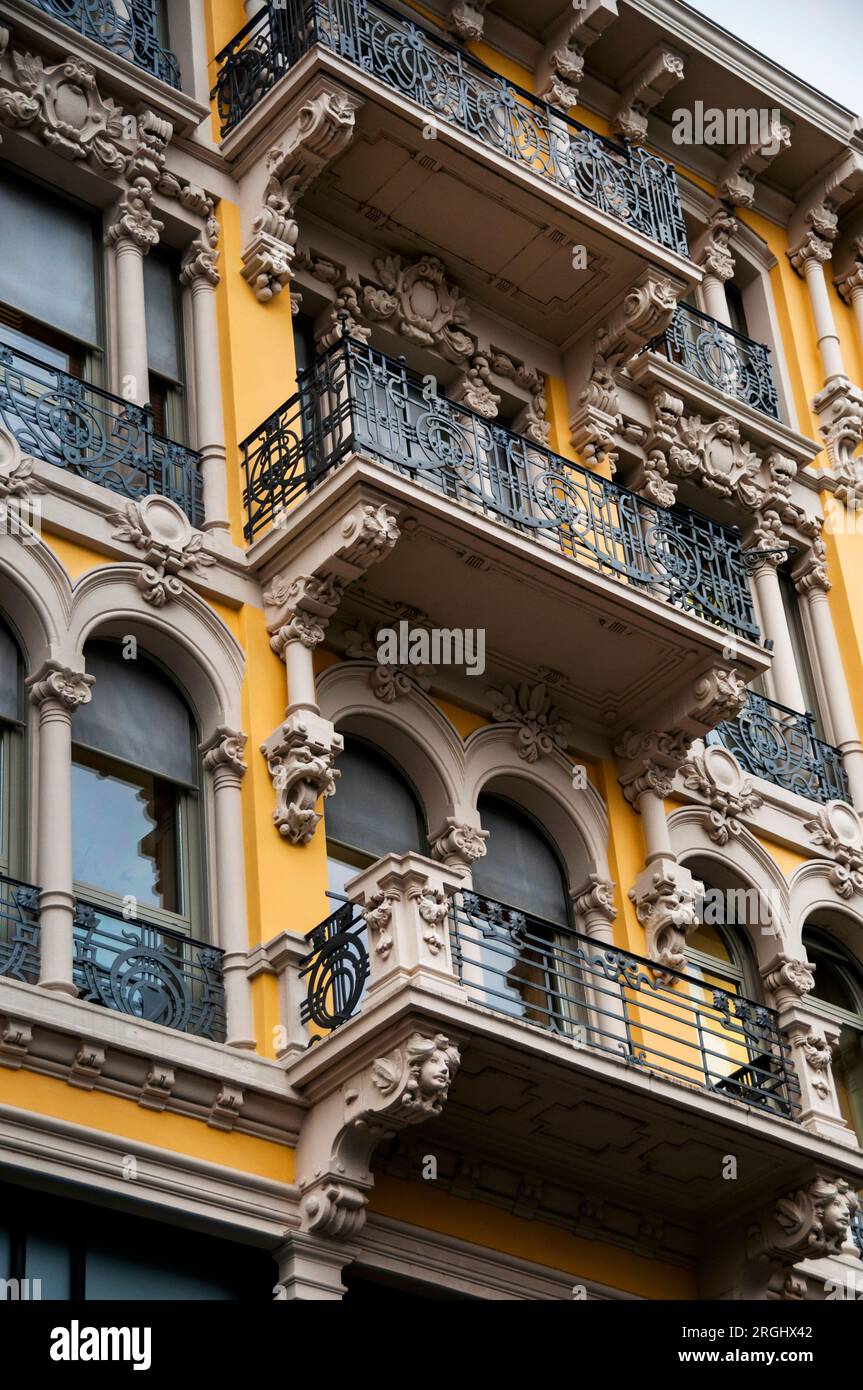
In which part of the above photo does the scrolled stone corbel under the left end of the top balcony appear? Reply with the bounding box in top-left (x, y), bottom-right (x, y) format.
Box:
top-left (242, 78), bottom-right (363, 303)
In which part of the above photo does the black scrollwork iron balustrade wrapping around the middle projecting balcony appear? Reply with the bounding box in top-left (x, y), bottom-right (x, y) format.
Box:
top-left (242, 339), bottom-right (759, 641)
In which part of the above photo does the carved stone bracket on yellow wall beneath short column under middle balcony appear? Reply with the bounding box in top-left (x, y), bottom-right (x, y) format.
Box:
top-left (261, 710), bottom-right (345, 845)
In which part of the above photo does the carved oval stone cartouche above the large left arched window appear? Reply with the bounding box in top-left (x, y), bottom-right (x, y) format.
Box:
top-left (108, 496), bottom-right (215, 607)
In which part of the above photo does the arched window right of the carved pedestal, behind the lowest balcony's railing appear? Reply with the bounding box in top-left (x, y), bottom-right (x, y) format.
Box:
top-left (457, 795), bottom-right (575, 1033)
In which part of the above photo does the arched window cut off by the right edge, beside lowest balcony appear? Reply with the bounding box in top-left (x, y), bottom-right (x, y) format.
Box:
top-left (803, 923), bottom-right (863, 1144)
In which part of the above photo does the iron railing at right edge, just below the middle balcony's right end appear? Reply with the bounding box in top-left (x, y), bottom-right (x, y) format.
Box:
top-left (706, 691), bottom-right (850, 802)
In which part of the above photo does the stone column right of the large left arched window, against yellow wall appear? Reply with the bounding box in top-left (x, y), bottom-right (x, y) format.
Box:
top-left (200, 727), bottom-right (254, 1048)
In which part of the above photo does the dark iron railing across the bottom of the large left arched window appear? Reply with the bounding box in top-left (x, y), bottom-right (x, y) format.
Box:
top-left (72, 899), bottom-right (225, 1043)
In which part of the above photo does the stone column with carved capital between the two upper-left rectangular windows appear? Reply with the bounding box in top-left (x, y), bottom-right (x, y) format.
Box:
top-left (106, 178), bottom-right (163, 406)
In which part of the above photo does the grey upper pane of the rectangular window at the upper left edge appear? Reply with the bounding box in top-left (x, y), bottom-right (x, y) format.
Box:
top-left (0, 174), bottom-right (99, 345)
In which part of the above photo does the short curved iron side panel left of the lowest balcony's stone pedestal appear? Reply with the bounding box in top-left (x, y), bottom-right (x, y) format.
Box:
top-left (300, 902), bottom-right (368, 1031)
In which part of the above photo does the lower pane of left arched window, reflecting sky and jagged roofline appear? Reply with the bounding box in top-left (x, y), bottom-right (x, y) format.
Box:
top-left (72, 752), bottom-right (182, 912)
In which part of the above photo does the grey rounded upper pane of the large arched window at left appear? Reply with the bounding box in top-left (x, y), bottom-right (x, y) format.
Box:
top-left (72, 644), bottom-right (197, 784)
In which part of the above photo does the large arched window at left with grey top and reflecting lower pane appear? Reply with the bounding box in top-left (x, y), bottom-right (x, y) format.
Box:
top-left (72, 642), bottom-right (204, 935)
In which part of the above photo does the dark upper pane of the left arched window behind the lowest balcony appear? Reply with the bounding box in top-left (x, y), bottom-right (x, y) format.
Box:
top-left (325, 739), bottom-right (424, 859)
